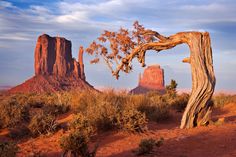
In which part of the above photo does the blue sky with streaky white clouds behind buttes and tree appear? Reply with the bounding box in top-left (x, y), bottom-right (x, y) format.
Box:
top-left (0, 0), bottom-right (236, 91)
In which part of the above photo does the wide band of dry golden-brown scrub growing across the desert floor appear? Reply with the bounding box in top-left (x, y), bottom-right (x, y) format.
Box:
top-left (0, 90), bottom-right (236, 156)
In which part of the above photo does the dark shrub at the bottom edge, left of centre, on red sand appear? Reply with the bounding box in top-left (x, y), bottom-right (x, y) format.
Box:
top-left (60, 131), bottom-right (97, 157)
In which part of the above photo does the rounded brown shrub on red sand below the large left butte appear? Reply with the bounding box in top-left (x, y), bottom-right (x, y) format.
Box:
top-left (28, 112), bottom-right (57, 136)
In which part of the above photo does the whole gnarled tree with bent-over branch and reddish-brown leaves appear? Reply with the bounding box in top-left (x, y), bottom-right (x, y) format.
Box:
top-left (86, 21), bottom-right (215, 128)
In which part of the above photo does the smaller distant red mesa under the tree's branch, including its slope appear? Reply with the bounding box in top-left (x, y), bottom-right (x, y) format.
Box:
top-left (130, 65), bottom-right (165, 94)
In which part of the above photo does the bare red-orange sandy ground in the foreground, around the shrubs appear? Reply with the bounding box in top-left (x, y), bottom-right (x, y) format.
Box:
top-left (1, 104), bottom-right (236, 157)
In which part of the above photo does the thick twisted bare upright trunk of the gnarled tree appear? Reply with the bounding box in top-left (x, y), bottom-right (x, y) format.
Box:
top-left (180, 33), bottom-right (215, 128)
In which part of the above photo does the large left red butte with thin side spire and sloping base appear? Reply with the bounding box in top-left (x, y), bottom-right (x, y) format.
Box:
top-left (9, 34), bottom-right (94, 93)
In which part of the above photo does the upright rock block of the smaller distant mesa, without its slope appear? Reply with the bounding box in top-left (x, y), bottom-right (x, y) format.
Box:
top-left (139, 65), bottom-right (165, 90)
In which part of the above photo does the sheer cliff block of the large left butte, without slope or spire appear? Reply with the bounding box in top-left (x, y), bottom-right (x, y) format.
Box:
top-left (34, 34), bottom-right (84, 77)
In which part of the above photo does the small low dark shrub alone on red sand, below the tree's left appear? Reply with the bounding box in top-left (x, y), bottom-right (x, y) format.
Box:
top-left (135, 138), bottom-right (164, 155)
